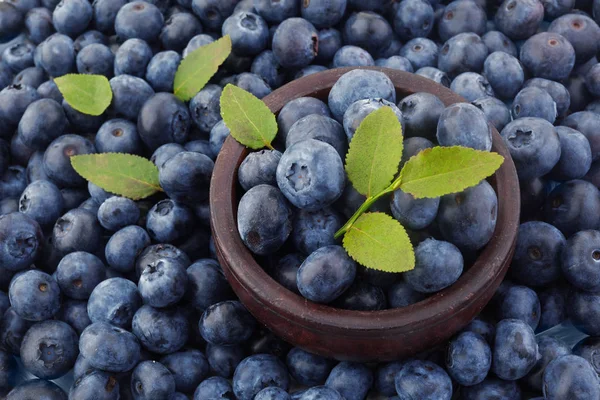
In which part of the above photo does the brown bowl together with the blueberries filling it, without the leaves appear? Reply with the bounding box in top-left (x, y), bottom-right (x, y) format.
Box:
top-left (210, 67), bottom-right (520, 362)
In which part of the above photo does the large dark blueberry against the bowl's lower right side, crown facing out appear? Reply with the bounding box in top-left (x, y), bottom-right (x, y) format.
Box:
top-left (510, 221), bottom-right (567, 287)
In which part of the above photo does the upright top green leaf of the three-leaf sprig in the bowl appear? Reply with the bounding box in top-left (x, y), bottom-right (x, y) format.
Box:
top-left (346, 107), bottom-right (402, 197)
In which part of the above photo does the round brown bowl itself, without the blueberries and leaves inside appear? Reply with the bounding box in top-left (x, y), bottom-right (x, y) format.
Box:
top-left (210, 67), bottom-right (520, 362)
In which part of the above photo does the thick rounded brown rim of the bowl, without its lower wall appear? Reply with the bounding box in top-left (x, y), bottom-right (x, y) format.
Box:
top-left (210, 67), bottom-right (520, 338)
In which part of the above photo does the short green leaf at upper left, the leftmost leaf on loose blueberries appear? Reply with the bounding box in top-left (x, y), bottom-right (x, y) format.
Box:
top-left (54, 74), bottom-right (112, 115)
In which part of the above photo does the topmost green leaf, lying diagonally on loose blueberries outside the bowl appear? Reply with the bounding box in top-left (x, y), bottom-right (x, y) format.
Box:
top-left (173, 35), bottom-right (231, 101)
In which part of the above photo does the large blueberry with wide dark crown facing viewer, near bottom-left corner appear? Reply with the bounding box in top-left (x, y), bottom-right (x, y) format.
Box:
top-left (21, 321), bottom-right (79, 379)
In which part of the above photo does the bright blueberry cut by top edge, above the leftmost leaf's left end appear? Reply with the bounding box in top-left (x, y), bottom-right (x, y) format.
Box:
top-left (52, 0), bottom-right (94, 37)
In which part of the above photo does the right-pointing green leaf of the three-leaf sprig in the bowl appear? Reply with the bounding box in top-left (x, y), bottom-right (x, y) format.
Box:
top-left (400, 146), bottom-right (504, 199)
